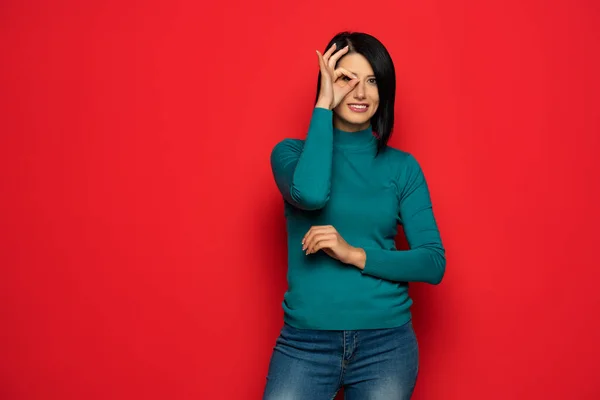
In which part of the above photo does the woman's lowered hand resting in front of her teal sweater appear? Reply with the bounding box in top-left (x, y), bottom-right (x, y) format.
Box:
top-left (302, 225), bottom-right (365, 268)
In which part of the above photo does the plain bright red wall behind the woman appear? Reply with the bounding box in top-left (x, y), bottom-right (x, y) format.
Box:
top-left (0, 0), bottom-right (600, 400)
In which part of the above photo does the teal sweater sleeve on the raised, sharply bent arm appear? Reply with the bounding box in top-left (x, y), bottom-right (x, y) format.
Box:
top-left (271, 107), bottom-right (333, 210)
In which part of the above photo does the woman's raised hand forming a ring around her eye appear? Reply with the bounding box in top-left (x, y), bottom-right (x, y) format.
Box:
top-left (317, 43), bottom-right (358, 110)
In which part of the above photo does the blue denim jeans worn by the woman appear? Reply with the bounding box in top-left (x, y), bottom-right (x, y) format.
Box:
top-left (263, 321), bottom-right (419, 400)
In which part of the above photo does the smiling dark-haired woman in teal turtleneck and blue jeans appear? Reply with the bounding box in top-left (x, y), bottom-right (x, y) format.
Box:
top-left (263, 32), bottom-right (446, 400)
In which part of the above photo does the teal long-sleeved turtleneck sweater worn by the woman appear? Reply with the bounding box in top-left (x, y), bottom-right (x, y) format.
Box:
top-left (271, 107), bottom-right (446, 330)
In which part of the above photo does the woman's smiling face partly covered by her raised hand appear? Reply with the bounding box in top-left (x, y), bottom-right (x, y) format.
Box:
top-left (333, 53), bottom-right (379, 132)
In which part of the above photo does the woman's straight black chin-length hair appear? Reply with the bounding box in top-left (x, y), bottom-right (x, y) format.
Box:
top-left (315, 32), bottom-right (396, 153)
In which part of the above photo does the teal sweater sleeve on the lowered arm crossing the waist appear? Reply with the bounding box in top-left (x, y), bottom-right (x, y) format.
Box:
top-left (361, 155), bottom-right (446, 285)
